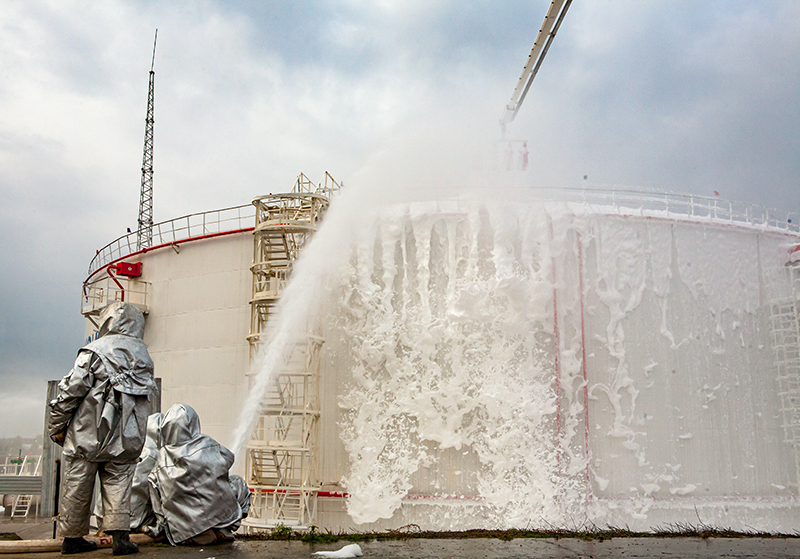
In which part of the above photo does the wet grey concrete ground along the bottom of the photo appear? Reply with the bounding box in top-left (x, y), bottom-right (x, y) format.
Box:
top-left (0, 518), bottom-right (800, 559)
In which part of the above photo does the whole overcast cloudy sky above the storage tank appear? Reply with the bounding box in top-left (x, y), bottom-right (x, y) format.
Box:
top-left (0, 0), bottom-right (800, 437)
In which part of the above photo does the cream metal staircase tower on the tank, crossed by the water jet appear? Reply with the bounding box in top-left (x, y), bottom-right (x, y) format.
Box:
top-left (243, 173), bottom-right (339, 530)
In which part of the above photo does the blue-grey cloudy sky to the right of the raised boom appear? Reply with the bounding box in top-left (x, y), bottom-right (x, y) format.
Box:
top-left (504, 2), bottom-right (800, 209)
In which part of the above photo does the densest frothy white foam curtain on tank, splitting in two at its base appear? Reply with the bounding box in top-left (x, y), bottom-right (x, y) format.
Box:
top-left (340, 203), bottom-right (572, 525)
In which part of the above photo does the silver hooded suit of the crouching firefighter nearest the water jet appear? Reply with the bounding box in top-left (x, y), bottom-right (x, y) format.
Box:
top-left (149, 404), bottom-right (242, 545)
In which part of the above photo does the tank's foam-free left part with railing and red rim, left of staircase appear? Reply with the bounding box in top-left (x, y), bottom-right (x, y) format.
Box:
top-left (83, 204), bottom-right (255, 445)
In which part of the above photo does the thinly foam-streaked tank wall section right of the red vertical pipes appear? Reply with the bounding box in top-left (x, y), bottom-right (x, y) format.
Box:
top-left (583, 219), bottom-right (797, 500)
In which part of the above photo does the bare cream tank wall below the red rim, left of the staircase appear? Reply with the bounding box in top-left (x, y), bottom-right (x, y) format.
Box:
top-left (136, 233), bottom-right (253, 446)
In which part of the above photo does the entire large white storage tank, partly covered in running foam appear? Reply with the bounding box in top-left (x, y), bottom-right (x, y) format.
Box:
top-left (85, 185), bottom-right (800, 532)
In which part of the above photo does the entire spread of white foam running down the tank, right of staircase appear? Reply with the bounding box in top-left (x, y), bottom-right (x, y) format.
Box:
top-left (234, 174), bottom-right (787, 528)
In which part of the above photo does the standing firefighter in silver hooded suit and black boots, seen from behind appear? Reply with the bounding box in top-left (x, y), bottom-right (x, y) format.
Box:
top-left (48, 303), bottom-right (158, 555)
